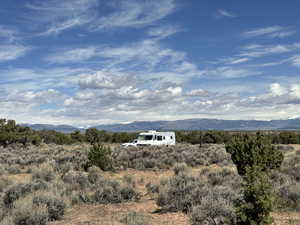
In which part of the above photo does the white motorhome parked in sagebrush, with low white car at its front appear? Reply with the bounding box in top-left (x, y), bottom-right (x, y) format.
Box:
top-left (122, 130), bottom-right (176, 147)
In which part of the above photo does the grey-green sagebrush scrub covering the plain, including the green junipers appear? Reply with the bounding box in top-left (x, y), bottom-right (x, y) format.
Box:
top-left (0, 121), bottom-right (300, 225)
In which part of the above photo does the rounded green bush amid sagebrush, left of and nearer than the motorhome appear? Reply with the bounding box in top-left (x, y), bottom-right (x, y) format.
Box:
top-left (88, 144), bottom-right (113, 171)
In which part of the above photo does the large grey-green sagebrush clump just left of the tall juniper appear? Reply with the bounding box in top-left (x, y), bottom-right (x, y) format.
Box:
top-left (156, 168), bottom-right (241, 213)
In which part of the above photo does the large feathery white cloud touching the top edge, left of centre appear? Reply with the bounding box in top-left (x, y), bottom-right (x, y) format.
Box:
top-left (26, 0), bottom-right (176, 35)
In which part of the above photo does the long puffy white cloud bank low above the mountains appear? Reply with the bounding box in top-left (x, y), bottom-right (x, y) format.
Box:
top-left (4, 71), bottom-right (300, 126)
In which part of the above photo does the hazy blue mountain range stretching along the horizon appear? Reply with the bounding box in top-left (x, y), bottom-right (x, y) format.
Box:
top-left (23, 118), bottom-right (300, 133)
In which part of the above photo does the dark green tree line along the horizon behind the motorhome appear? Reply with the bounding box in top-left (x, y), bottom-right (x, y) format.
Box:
top-left (0, 119), bottom-right (300, 146)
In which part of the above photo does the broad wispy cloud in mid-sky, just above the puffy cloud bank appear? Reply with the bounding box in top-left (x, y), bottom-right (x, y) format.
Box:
top-left (45, 38), bottom-right (199, 82)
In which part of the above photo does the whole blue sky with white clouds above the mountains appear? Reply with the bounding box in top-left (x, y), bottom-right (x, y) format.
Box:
top-left (0, 0), bottom-right (300, 127)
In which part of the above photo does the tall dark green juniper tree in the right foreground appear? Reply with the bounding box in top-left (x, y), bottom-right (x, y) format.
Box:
top-left (226, 133), bottom-right (283, 225)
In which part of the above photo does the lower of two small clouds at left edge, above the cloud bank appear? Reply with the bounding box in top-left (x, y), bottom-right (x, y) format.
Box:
top-left (0, 44), bottom-right (31, 62)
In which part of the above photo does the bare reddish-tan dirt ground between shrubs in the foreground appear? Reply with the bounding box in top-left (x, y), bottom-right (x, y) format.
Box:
top-left (51, 167), bottom-right (300, 225)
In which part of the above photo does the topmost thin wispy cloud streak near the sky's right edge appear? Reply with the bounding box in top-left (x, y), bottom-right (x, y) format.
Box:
top-left (242, 26), bottom-right (296, 38)
